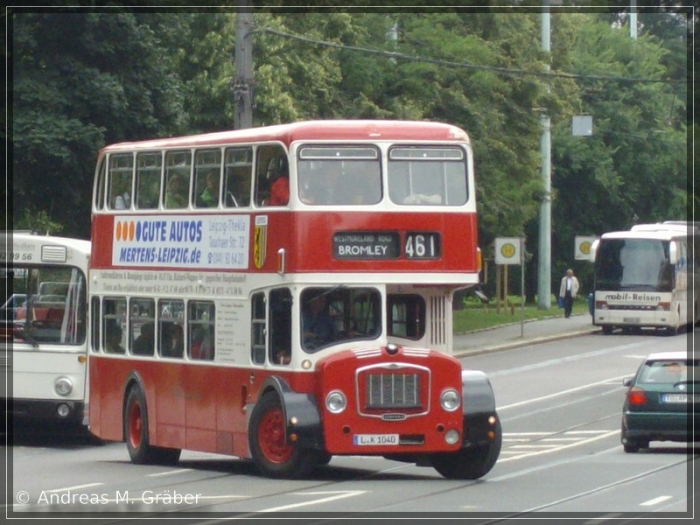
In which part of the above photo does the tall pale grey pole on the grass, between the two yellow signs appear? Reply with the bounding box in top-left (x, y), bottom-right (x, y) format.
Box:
top-left (537, 0), bottom-right (552, 310)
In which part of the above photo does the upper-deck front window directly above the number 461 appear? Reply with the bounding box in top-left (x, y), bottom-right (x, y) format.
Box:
top-left (388, 146), bottom-right (469, 206)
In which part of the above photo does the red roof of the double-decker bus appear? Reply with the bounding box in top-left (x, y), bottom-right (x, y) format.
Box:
top-left (102, 120), bottom-right (469, 153)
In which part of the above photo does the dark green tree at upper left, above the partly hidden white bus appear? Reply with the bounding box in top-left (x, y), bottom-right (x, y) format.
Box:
top-left (10, 10), bottom-right (184, 238)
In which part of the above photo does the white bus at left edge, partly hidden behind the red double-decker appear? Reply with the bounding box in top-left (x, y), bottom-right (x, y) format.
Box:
top-left (0, 231), bottom-right (90, 426)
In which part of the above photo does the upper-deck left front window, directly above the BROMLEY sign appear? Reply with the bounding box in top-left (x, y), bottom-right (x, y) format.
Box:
top-left (297, 146), bottom-right (382, 206)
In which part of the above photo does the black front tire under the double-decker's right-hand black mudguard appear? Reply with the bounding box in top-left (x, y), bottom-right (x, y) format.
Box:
top-left (430, 420), bottom-right (503, 479)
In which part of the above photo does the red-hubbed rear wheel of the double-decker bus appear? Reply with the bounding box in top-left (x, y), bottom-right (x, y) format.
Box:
top-left (124, 387), bottom-right (180, 465)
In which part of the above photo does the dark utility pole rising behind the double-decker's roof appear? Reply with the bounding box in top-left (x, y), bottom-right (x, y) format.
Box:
top-left (233, 0), bottom-right (253, 129)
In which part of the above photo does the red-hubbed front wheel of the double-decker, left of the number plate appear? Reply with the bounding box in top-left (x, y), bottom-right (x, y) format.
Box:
top-left (248, 392), bottom-right (319, 478)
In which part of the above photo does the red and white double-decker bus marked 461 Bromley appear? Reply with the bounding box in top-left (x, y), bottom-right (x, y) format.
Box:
top-left (89, 121), bottom-right (501, 479)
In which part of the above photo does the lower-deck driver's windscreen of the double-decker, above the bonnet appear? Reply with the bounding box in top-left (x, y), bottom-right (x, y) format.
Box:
top-left (301, 286), bottom-right (382, 353)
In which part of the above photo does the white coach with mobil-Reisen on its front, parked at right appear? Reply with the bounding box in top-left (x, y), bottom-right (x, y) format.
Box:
top-left (593, 221), bottom-right (700, 335)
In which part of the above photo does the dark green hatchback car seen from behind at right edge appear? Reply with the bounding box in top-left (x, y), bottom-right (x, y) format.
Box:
top-left (621, 352), bottom-right (700, 452)
